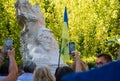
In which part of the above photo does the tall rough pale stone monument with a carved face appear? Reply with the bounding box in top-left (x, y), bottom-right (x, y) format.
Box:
top-left (15, 0), bottom-right (63, 73)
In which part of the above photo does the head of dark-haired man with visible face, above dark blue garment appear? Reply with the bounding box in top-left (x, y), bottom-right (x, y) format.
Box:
top-left (96, 53), bottom-right (112, 67)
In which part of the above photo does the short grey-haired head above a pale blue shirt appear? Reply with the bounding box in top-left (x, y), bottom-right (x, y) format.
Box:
top-left (23, 61), bottom-right (36, 73)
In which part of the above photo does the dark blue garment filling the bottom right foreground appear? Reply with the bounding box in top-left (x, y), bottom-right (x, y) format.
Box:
top-left (61, 60), bottom-right (120, 81)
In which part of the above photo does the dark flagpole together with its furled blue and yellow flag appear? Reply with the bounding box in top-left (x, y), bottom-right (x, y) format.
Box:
top-left (58, 7), bottom-right (69, 67)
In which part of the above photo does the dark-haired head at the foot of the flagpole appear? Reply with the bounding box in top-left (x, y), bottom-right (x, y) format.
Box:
top-left (55, 66), bottom-right (74, 81)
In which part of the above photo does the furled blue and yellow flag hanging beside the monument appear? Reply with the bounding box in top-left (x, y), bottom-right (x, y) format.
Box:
top-left (60, 7), bottom-right (70, 62)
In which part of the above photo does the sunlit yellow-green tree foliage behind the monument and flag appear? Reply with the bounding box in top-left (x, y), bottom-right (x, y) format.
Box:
top-left (0, 0), bottom-right (120, 62)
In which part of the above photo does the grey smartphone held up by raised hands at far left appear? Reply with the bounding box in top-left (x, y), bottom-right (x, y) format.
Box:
top-left (4, 38), bottom-right (13, 53)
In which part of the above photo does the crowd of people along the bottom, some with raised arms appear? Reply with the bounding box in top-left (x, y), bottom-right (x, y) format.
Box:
top-left (0, 46), bottom-right (120, 81)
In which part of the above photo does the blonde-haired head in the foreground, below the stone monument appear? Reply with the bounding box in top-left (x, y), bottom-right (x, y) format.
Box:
top-left (34, 66), bottom-right (55, 81)
